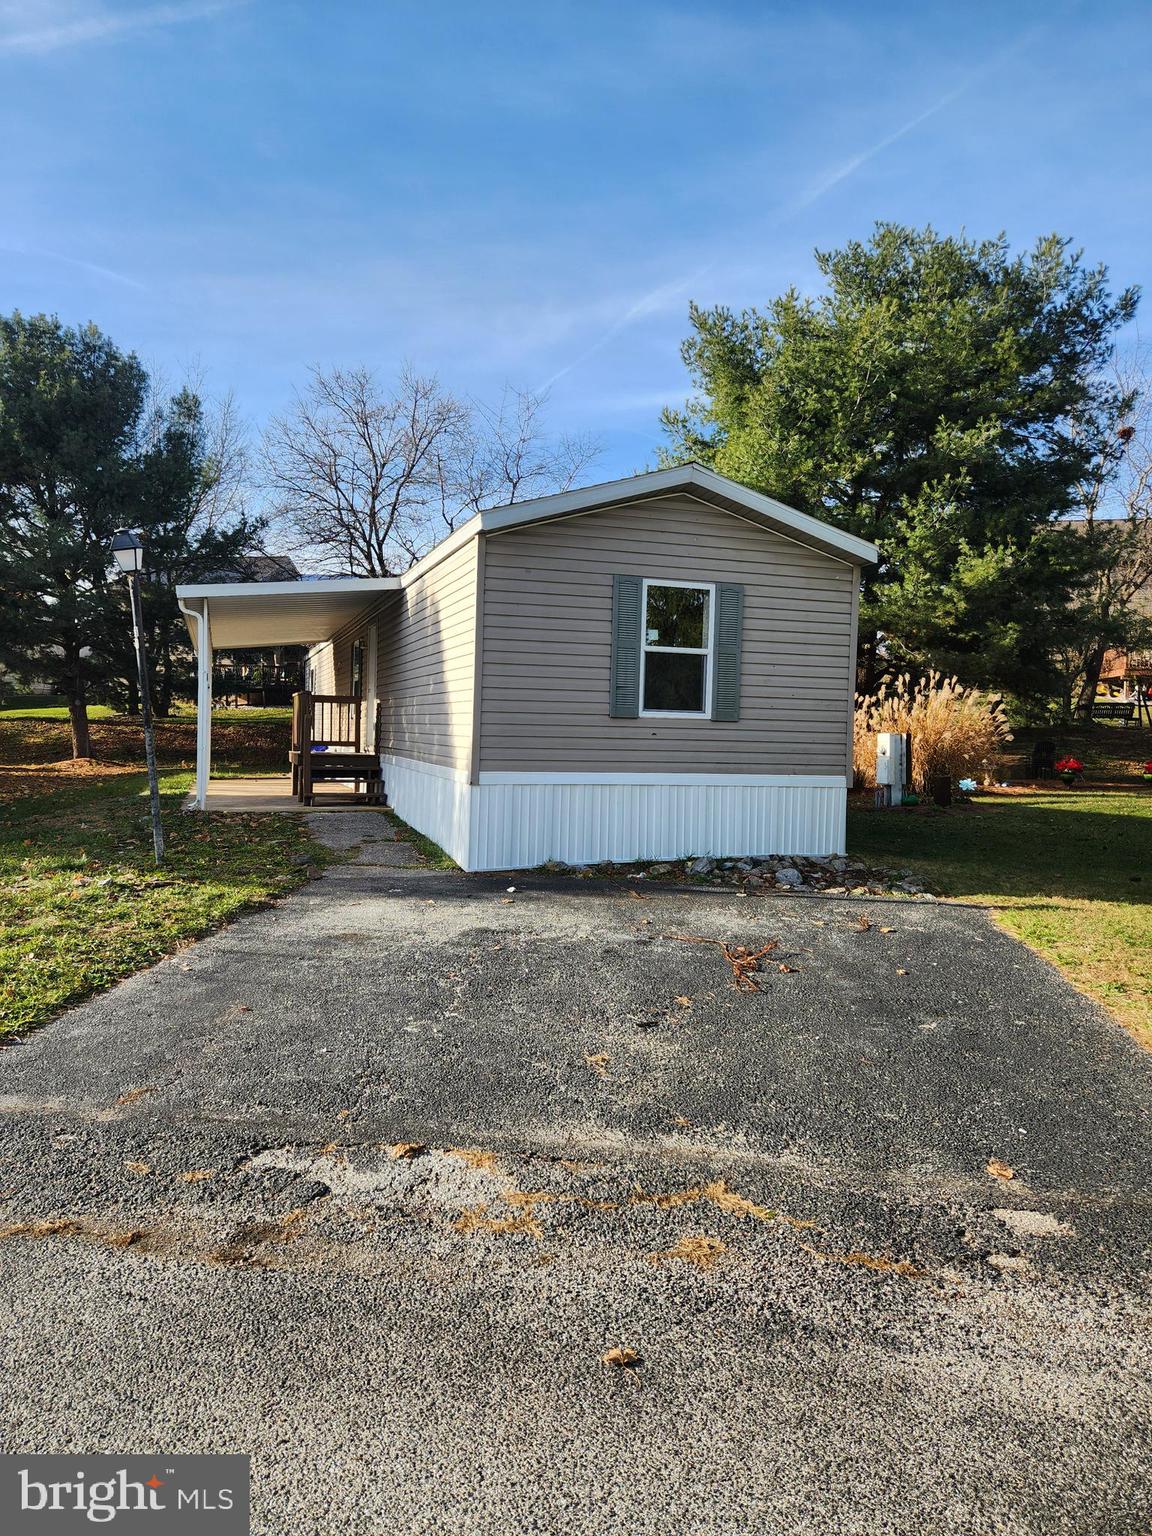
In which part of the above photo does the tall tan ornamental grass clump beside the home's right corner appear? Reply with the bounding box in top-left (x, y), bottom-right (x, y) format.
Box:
top-left (852, 673), bottom-right (1012, 794)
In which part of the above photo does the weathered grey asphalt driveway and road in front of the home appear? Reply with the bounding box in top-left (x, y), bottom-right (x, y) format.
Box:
top-left (0, 820), bottom-right (1152, 1536)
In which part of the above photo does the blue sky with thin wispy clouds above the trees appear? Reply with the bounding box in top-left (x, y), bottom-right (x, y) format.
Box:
top-left (0, 0), bottom-right (1152, 478)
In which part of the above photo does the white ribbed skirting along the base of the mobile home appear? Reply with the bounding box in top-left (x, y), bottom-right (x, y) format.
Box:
top-left (382, 757), bottom-right (846, 869)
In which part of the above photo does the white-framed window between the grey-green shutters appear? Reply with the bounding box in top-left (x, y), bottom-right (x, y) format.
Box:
top-left (641, 581), bottom-right (713, 714)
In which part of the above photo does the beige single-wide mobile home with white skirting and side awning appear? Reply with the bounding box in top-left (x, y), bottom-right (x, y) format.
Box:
top-left (180, 465), bottom-right (877, 869)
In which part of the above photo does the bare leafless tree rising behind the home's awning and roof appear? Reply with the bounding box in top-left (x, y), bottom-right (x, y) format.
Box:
top-left (263, 367), bottom-right (598, 576)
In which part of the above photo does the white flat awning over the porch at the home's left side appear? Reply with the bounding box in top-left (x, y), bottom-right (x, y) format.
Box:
top-left (177, 576), bottom-right (399, 650)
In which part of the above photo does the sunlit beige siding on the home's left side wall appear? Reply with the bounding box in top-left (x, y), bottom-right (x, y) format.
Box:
top-left (371, 539), bottom-right (479, 771)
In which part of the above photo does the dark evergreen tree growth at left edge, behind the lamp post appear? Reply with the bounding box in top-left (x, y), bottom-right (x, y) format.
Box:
top-left (0, 313), bottom-right (260, 757)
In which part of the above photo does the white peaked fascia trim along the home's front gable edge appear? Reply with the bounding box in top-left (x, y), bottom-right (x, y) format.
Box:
top-left (473, 464), bottom-right (880, 565)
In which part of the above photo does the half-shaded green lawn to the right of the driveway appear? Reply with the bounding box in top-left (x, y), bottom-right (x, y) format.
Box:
top-left (848, 782), bottom-right (1152, 1046)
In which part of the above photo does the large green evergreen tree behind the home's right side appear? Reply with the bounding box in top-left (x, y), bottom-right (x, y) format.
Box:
top-left (664, 224), bottom-right (1137, 693)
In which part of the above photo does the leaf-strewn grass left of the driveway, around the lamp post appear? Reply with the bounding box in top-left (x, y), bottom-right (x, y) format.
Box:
top-left (0, 774), bottom-right (330, 1035)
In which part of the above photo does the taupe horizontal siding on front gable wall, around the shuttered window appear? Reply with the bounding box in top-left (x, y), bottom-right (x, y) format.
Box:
top-left (479, 496), bottom-right (859, 774)
